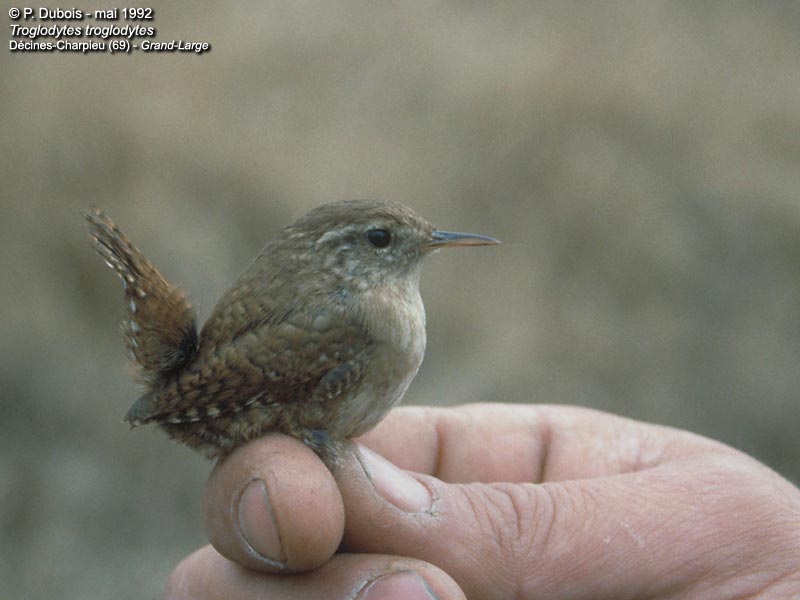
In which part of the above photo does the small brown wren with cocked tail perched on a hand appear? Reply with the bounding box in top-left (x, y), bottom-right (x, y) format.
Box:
top-left (86, 201), bottom-right (499, 466)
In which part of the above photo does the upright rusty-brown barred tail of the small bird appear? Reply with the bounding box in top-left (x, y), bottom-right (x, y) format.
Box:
top-left (85, 209), bottom-right (197, 418)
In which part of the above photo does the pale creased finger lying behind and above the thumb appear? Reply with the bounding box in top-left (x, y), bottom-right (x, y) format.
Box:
top-left (358, 404), bottom-right (735, 483)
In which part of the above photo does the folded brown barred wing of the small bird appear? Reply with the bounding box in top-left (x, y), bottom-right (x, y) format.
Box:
top-left (127, 304), bottom-right (371, 424)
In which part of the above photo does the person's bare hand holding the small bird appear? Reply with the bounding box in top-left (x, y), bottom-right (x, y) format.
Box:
top-left (166, 404), bottom-right (800, 600)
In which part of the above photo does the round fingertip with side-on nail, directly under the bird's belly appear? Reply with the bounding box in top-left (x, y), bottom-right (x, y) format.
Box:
top-left (204, 434), bottom-right (344, 573)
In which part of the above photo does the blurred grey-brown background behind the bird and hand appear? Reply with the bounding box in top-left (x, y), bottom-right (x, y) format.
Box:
top-left (0, 0), bottom-right (800, 599)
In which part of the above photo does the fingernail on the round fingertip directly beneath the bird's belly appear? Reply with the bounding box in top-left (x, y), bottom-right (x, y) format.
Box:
top-left (239, 479), bottom-right (286, 567)
